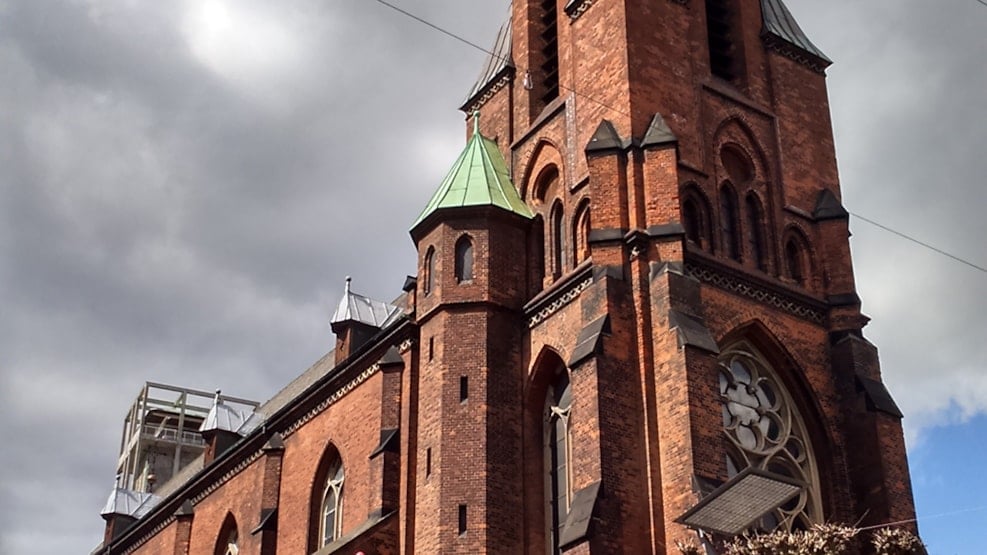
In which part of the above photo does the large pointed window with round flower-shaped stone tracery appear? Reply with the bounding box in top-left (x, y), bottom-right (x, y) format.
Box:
top-left (719, 342), bottom-right (822, 530)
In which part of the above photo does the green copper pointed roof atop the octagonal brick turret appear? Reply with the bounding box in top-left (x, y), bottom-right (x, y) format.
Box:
top-left (411, 113), bottom-right (534, 233)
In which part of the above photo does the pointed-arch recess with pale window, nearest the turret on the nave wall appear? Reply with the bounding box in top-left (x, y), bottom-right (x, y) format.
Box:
top-left (308, 443), bottom-right (346, 553)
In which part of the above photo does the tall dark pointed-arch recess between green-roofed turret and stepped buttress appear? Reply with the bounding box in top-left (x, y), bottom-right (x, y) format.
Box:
top-left (524, 346), bottom-right (573, 553)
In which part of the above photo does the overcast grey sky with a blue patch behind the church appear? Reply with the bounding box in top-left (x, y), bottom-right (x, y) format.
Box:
top-left (0, 0), bottom-right (987, 555)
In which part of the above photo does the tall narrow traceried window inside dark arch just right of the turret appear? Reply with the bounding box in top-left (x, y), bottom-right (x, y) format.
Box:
top-left (545, 368), bottom-right (572, 553)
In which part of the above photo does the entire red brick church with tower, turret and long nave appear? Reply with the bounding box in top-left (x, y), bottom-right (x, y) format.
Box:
top-left (94, 0), bottom-right (915, 555)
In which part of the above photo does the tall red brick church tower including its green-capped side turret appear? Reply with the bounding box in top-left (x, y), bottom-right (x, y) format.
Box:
top-left (430, 0), bottom-right (914, 553)
